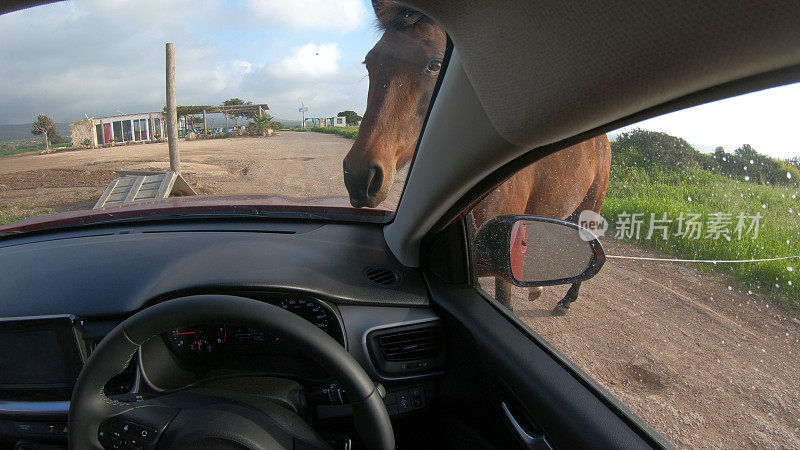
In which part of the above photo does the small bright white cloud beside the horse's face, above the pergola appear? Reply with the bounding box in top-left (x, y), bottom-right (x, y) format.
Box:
top-left (267, 43), bottom-right (342, 79)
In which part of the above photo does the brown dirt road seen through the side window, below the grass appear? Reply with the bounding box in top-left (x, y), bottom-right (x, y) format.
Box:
top-left (489, 239), bottom-right (800, 448)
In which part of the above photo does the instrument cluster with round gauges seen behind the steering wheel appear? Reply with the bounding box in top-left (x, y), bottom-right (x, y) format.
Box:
top-left (163, 295), bottom-right (344, 361)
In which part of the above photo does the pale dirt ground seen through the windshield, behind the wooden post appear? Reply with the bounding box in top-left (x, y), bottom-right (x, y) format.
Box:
top-left (0, 131), bottom-right (407, 212)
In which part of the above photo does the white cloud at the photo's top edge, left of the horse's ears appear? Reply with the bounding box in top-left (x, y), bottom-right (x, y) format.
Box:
top-left (248, 0), bottom-right (369, 31)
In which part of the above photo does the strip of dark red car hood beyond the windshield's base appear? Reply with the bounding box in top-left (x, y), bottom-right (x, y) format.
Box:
top-left (0, 195), bottom-right (394, 234)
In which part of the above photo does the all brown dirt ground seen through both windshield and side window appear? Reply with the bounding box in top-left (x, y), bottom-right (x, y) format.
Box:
top-left (0, 132), bottom-right (800, 448)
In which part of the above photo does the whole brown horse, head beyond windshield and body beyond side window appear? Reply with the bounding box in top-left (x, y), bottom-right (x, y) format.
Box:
top-left (343, 0), bottom-right (611, 312)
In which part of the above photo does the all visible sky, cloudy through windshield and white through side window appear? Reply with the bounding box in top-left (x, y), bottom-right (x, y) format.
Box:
top-left (0, 0), bottom-right (800, 159)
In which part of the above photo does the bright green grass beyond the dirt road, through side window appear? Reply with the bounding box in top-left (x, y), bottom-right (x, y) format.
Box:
top-left (602, 164), bottom-right (800, 309)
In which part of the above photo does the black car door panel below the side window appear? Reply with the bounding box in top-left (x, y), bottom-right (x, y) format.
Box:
top-left (427, 274), bottom-right (669, 449)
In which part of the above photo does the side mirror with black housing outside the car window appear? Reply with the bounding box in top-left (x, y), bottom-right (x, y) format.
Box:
top-left (474, 215), bottom-right (606, 287)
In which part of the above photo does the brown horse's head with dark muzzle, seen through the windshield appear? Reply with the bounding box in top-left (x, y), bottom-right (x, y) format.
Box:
top-left (343, 0), bottom-right (447, 208)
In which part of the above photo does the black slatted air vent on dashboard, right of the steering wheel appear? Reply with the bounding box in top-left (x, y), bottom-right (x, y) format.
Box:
top-left (367, 322), bottom-right (445, 376)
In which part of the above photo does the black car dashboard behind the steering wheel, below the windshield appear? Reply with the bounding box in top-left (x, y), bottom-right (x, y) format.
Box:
top-left (0, 221), bottom-right (445, 447)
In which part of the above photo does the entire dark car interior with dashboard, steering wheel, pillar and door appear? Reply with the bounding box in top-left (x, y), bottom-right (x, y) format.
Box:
top-left (0, 0), bottom-right (800, 449)
